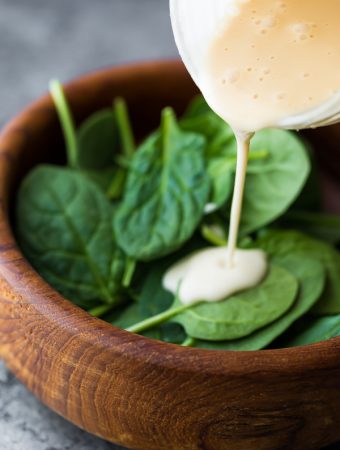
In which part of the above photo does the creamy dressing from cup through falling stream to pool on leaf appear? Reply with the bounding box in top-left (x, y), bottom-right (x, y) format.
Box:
top-left (163, 0), bottom-right (340, 304)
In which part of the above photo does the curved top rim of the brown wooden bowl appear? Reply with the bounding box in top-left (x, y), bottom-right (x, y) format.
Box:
top-left (0, 59), bottom-right (340, 374)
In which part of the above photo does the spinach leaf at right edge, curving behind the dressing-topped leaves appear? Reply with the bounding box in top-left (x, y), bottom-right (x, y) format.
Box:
top-left (256, 231), bottom-right (340, 315)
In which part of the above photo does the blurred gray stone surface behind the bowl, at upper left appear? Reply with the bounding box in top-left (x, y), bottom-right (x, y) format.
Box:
top-left (0, 0), bottom-right (177, 127)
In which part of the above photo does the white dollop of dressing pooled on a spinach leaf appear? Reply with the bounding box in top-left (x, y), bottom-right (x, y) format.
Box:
top-left (163, 247), bottom-right (267, 305)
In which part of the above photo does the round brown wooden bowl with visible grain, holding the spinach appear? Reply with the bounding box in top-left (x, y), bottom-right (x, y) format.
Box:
top-left (0, 61), bottom-right (340, 450)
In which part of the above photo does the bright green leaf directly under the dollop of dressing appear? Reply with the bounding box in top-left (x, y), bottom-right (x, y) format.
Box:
top-left (172, 266), bottom-right (298, 341)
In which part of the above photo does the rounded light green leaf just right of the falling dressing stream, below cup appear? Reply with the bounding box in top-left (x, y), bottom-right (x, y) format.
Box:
top-left (240, 130), bottom-right (310, 235)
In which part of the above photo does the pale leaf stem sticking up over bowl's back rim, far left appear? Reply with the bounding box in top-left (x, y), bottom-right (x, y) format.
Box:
top-left (50, 80), bottom-right (78, 168)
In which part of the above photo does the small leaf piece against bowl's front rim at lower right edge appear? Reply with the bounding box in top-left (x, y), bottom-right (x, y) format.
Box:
top-left (280, 315), bottom-right (340, 347)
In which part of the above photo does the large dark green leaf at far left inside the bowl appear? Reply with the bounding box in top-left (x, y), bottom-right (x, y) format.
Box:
top-left (16, 166), bottom-right (125, 308)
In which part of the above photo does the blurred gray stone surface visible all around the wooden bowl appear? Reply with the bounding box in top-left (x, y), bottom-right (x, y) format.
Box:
top-left (0, 0), bottom-right (177, 450)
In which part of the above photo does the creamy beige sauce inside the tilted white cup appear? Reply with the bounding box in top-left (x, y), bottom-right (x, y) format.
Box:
top-left (202, 0), bottom-right (340, 131)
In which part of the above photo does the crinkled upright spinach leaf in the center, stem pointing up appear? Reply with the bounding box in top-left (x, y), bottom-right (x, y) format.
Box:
top-left (114, 109), bottom-right (210, 261)
